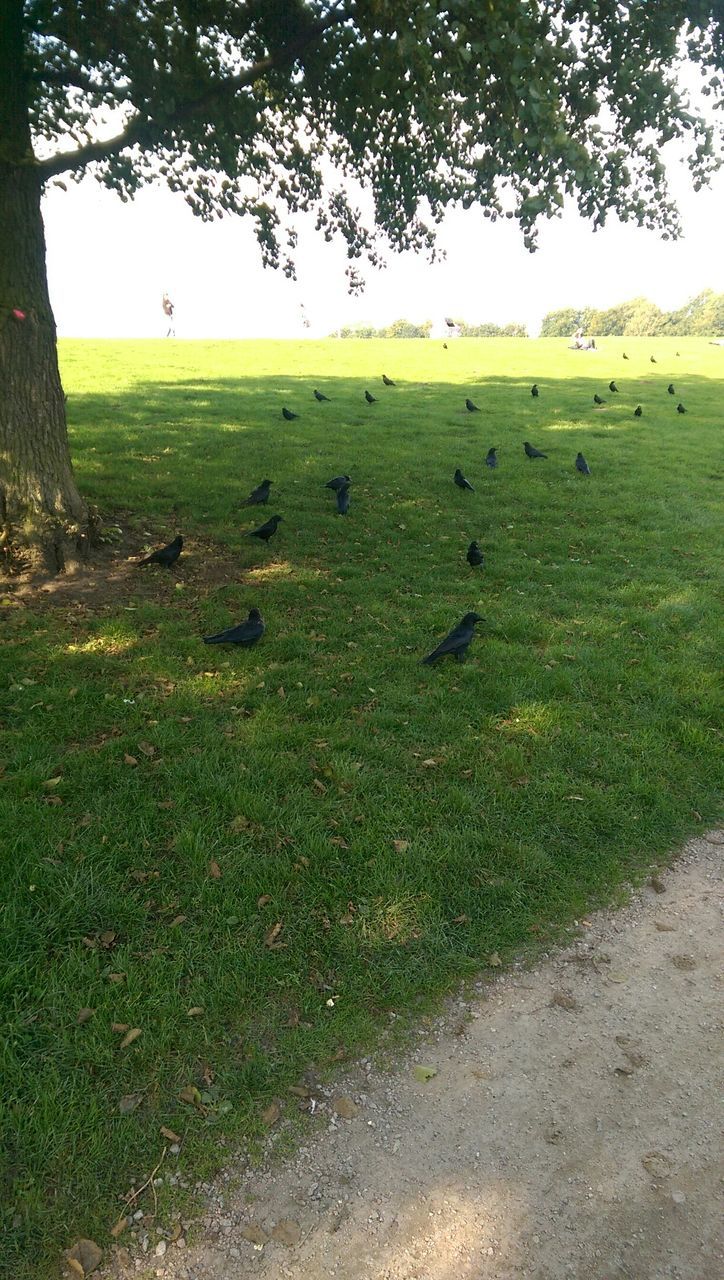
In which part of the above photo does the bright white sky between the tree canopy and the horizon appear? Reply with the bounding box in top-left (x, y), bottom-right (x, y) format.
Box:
top-left (43, 85), bottom-right (724, 338)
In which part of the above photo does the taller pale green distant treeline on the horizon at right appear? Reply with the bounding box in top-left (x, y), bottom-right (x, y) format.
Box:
top-left (541, 289), bottom-right (724, 338)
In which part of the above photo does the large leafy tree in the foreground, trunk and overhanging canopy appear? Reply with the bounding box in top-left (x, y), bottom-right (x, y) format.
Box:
top-left (0, 0), bottom-right (724, 568)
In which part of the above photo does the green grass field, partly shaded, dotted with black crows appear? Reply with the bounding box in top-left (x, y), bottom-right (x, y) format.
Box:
top-left (0, 339), bottom-right (724, 1280)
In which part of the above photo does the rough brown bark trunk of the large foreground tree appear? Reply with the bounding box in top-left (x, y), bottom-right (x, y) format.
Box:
top-left (0, 0), bottom-right (93, 573)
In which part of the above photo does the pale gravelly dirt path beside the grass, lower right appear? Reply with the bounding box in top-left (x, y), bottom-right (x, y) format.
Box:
top-left (116, 832), bottom-right (724, 1280)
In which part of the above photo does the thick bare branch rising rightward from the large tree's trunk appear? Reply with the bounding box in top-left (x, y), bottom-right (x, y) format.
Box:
top-left (36, 0), bottom-right (350, 180)
